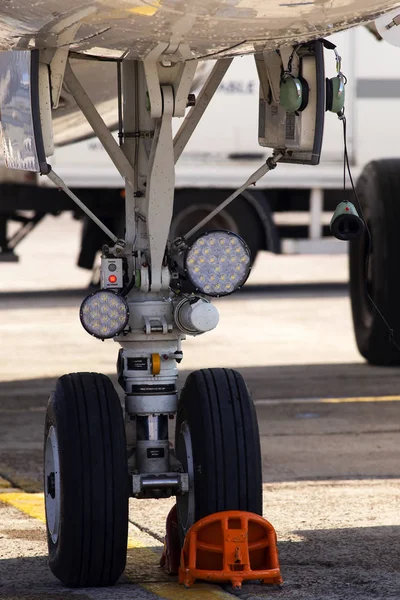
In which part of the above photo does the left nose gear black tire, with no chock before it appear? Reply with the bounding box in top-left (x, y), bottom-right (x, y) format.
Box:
top-left (44, 373), bottom-right (129, 587)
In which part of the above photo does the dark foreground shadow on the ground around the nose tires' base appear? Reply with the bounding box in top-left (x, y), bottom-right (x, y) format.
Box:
top-left (0, 527), bottom-right (400, 600)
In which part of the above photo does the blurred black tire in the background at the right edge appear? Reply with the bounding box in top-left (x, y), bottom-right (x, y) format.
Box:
top-left (349, 159), bottom-right (400, 365)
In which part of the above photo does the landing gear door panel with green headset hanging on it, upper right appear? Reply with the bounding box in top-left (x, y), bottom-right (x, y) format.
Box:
top-left (255, 41), bottom-right (326, 165)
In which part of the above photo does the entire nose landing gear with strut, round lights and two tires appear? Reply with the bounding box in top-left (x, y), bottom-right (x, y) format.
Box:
top-left (45, 50), bottom-right (273, 586)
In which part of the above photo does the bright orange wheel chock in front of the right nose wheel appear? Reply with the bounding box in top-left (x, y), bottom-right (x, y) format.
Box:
top-left (179, 510), bottom-right (283, 588)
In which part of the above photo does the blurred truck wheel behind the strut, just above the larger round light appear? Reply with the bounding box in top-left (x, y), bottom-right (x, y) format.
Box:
top-left (170, 189), bottom-right (265, 262)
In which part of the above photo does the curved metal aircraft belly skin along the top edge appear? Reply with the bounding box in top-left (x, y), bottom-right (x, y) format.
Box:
top-left (0, 0), bottom-right (400, 59)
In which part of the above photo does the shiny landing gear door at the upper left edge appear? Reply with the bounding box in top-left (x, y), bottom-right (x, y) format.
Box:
top-left (0, 50), bottom-right (53, 173)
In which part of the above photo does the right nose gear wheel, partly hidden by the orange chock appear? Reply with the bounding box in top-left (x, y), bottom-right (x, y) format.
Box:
top-left (175, 369), bottom-right (262, 542)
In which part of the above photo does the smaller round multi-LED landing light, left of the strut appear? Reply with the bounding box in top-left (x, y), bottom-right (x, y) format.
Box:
top-left (80, 290), bottom-right (129, 340)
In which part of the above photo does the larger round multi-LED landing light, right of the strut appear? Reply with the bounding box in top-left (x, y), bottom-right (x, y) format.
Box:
top-left (185, 230), bottom-right (251, 297)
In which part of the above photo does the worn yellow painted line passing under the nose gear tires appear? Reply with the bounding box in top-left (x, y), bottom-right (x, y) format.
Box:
top-left (0, 492), bottom-right (238, 600)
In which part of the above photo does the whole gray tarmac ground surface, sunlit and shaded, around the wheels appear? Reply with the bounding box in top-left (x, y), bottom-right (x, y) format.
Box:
top-left (0, 216), bottom-right (400, 600)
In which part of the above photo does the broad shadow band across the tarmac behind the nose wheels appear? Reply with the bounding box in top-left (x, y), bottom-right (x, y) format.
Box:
top-left (0, 363), bottom-right (400, 492)
